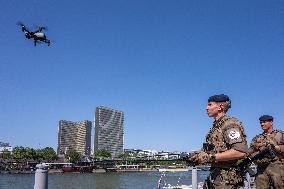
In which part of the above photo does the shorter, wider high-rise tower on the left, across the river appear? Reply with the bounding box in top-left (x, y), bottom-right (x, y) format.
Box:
top-left (57, 120), bottom-right (92, 156)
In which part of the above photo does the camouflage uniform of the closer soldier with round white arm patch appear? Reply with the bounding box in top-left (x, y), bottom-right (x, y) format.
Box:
top-left (202, 115), bottom-right (248, 189)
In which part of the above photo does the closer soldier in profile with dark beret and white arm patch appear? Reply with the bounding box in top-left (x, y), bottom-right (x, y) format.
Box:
top-left (187, 94), bottom-right (248, 189)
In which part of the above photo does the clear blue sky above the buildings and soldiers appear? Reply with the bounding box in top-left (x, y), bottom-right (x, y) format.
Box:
top-left (0, 0), bottom-right (284, 151)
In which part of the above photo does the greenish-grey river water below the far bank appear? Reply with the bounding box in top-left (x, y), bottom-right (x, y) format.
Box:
top-left (0, 171), bottom-right (208, 189)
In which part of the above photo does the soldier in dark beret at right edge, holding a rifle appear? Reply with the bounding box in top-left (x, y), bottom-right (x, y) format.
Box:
top-left (249, 115), bottom-right (284, 189)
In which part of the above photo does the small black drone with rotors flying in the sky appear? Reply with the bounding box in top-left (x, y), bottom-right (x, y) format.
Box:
top-left (18, 22), bottom-right (50, 46)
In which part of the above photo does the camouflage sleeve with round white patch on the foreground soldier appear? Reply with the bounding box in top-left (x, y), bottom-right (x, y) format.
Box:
top-left (224, 123), bottom-right (248, 153)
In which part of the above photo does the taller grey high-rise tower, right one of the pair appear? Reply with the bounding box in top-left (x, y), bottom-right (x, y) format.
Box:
top-left (94, 106), bottom-right (124, 157)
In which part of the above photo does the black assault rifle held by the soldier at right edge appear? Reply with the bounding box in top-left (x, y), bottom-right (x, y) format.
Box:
top-left (237, 144), bottom-right (277, 176)
